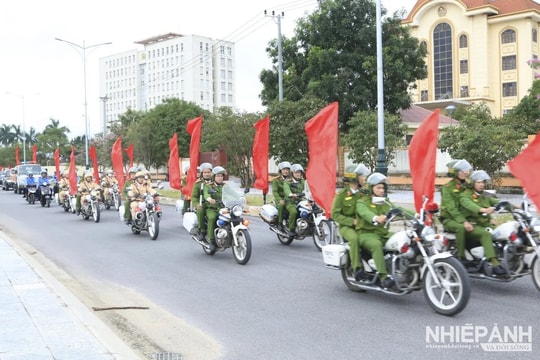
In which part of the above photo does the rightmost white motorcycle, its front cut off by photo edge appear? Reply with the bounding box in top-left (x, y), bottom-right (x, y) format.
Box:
top-left (440, 199), bottom-right (540, 290)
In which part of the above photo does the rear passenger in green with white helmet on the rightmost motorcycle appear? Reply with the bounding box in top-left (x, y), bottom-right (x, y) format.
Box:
top-left (441, 159), bottom-right (472, 261)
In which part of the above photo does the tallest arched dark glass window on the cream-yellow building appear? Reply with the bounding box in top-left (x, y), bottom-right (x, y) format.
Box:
top-left (433, 23), bottom-right (453, 100)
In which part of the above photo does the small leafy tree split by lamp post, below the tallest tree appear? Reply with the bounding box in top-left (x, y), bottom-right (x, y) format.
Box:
top-left (344, 111), bottom-right (407, 169)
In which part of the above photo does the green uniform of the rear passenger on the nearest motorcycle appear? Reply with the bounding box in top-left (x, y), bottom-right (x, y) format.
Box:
top-left (332, 185), bottom-right (365, 271)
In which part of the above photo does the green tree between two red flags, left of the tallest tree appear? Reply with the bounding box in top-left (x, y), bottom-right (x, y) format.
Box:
top-left (268, 97), bottom-right (328, 167)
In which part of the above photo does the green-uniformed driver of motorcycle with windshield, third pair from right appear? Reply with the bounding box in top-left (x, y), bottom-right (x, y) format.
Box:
top-left (203, 166), bottom-right (227, 251)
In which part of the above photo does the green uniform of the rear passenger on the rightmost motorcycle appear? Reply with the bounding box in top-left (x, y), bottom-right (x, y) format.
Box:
top-left (441, 178), bottom-right (467, 259)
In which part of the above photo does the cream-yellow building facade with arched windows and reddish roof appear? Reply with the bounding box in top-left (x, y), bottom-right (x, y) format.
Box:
top-left (403, 0), bottom-right (540, 117)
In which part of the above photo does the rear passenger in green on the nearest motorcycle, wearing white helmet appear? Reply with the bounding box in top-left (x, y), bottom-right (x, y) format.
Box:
top-left (332, 164), bottom-right (370, 281)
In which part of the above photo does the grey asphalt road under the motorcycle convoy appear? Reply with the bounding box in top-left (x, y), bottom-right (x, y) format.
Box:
top-left (0, 191), bottom-right (540, 360)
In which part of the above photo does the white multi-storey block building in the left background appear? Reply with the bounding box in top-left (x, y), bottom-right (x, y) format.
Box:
top-left (99, 33), bottom-right (236, 127)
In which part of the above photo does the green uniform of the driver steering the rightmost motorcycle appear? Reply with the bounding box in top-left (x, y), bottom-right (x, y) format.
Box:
top-left (459, 189), bottom-right (499, 265)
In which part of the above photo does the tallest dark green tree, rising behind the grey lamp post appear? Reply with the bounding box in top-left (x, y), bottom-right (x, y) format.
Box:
top-left (260, 0), bottom-right (426, 132)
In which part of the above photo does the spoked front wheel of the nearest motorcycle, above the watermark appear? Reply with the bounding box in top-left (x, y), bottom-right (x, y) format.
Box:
top-left (423, 258), bottom-right (471, 316)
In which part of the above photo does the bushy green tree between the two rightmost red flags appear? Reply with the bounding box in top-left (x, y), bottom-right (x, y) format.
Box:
top-left (439, 104), bottom-right (524, 180)
